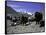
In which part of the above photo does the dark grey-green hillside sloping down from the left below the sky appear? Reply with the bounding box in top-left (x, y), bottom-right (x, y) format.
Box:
top-left (6, 6), bottom-right (31, 17)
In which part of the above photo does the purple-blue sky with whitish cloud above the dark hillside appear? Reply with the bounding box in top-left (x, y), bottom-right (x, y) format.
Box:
top-left (7, 1), bottom-right (45, 14)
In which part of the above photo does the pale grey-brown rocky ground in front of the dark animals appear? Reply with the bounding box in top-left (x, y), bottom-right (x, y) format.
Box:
top-left (7, 20), bottom-right (44, 34)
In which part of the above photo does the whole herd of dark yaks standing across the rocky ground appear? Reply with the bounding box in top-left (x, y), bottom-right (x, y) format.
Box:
top-left (6, 12), bottom-right (45, 27)
